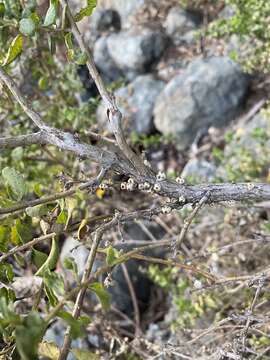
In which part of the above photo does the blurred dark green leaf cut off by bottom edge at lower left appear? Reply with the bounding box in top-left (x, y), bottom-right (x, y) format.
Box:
top-left (15, 312), bottom-right (46, 360)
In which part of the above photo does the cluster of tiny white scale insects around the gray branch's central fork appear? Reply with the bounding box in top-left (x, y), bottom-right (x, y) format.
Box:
top-left (99, 171), bottom-right (186, 214)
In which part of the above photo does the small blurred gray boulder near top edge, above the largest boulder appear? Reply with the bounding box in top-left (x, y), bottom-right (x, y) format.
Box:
top-left (164, 6), bottom-right (201, 45)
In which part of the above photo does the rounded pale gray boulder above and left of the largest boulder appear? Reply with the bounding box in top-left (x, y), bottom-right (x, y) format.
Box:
top-left (107, 28), bottom-right (166, 73)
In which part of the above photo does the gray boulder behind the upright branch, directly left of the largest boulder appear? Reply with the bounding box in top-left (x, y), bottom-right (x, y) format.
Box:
top-left (97, 75), bottom-right (165, 134)
